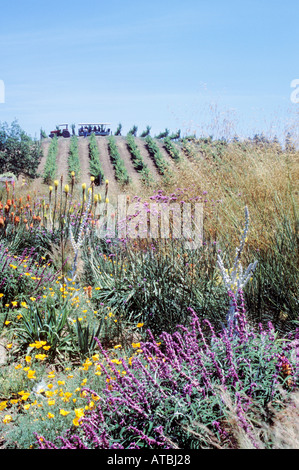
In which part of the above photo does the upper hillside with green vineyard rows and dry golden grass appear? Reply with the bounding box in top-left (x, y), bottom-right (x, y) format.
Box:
top-left (33, 132), bottom-right (299, 253)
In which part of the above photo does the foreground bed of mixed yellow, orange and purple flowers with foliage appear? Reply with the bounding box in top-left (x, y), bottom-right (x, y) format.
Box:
top-left (0, 175), bottom-right (299, 449)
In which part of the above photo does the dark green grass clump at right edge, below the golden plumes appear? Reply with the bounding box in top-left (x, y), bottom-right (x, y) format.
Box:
top-left (246, 201), bottom-right (299, 331)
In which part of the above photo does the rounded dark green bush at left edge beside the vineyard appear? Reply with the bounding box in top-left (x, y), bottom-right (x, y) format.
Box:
top-left (0, 121), bottom-right (42, 178)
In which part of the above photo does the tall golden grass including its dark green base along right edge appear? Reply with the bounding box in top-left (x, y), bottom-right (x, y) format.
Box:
top-left (163, 137), bottom-right (299, 331)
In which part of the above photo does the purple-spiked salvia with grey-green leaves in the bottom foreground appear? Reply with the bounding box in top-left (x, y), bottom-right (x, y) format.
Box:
top-left (37, 302), bottom-right (298, 449)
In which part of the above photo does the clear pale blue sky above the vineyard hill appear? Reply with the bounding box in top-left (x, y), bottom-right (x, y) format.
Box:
top-left (0, 0), bottom-right (299, 137)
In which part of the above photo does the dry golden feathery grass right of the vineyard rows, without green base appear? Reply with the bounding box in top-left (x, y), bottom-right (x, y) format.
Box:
top-left (163, 141), bottom-right (299, 253)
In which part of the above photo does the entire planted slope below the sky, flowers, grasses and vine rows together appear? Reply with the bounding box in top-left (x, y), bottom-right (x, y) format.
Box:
top-left (0, 136), bottom-right (299, 449)
